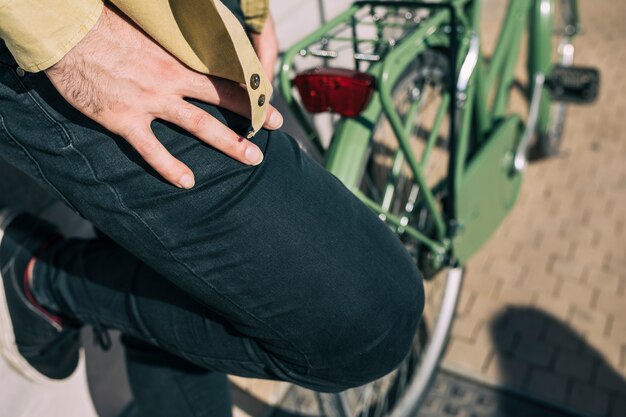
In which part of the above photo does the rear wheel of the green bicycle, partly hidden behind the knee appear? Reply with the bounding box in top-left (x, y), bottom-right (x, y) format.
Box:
top-left (310, 50), bottom-right (462, 417)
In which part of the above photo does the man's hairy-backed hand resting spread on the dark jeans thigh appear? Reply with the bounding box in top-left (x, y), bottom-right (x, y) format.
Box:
top-left (46, 5), bottom-right (283, 188)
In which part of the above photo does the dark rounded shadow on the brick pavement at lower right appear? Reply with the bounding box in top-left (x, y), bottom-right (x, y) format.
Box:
top-left (490, 307), bottom-right (626, 417)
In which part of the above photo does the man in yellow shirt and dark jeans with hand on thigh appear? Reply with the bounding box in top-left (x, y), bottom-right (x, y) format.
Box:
top-left (0, 0), bottom-right (423, 415)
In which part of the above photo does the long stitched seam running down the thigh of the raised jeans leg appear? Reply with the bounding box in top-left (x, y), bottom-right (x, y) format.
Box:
top-left (68, 139), bottom-right (311, 366)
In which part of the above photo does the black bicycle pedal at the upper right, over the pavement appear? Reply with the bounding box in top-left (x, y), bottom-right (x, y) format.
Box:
top-left (547, 65), bottom-right (600, 103)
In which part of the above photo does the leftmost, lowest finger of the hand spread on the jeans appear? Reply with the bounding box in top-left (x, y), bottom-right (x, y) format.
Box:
top-left (122, 125), bottom-right (195, 189)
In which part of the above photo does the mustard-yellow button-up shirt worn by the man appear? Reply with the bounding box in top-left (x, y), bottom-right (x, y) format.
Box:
top-left (0, 0), bottom-right (272, 136)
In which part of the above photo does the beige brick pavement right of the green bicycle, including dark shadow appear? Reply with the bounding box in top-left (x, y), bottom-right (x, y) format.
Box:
top-left (444, 0), bottom-right (626, 417)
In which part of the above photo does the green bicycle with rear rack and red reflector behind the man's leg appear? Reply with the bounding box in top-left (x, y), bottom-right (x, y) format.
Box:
top-left (234, 0), bottom-right (599, 417)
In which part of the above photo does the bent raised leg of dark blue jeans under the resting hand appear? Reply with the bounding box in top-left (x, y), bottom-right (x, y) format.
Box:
top-left (0, 39), bottom-right (424, 415)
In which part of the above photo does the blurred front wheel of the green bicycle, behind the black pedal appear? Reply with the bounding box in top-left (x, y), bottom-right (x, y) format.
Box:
top-left (530, 0), bottom-right (576, 159)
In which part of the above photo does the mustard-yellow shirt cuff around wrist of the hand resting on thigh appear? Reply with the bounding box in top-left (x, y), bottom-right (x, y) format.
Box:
top-left (0, 0), bottom-right (103, 72)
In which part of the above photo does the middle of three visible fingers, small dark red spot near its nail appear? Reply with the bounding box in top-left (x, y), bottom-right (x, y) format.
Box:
top-left (158, 99), bottom-right (263, 165)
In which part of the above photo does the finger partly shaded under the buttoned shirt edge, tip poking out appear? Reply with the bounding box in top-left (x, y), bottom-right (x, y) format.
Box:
top-left (181, 72), bottom-right (283, 130)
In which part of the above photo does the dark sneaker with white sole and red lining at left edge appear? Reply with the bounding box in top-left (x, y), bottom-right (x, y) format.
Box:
top-left (0, 209), bottom-right (81, 382)
